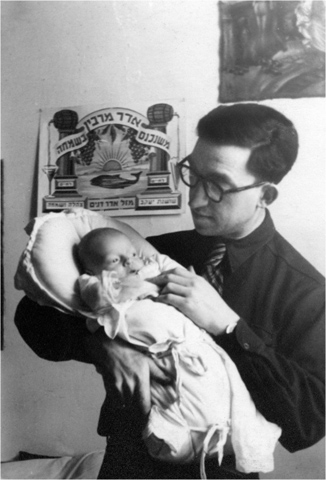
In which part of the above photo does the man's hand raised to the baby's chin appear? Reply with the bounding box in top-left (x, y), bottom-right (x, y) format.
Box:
top-left (150, 268), bottom-right (239, 335)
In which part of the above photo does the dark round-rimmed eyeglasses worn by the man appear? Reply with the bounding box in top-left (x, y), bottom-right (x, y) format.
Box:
top-left (177, 157), bottom-right (268, 203)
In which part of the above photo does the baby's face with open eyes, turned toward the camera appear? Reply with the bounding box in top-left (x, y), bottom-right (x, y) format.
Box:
top-left (94, 235), bottom-right (144, 279)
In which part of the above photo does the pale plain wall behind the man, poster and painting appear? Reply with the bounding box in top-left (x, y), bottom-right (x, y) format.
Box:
top-left (2, 0), bottom-right (326, 478)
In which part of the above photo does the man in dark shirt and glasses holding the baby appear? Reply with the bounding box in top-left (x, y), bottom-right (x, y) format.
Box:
top-left (16, 104), bottom-right (324, 478)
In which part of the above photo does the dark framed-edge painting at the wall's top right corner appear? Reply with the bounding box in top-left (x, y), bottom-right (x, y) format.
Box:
top-left (218, 0), bottom-right (325, 102)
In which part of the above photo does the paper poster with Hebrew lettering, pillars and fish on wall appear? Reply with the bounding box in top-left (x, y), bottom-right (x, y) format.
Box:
top-left (38, 101), bottom-right (184, 216)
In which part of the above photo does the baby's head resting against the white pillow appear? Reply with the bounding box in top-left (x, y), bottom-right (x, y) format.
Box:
top-left (78, 228), bottom-right (144, 279)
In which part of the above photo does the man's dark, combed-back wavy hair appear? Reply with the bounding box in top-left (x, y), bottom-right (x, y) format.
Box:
top-left (197, 103), bottom-right (299, 184)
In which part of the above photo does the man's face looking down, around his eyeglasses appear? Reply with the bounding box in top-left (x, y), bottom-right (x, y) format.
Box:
top-left (189, 140), bottom-right (265, 239)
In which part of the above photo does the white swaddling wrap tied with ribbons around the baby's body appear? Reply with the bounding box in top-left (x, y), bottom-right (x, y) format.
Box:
top-left (80, 258), bottom-right (281, 478)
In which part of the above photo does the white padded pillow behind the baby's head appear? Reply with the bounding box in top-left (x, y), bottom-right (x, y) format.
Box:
top-left (15, 208), bottom-right (157, 315)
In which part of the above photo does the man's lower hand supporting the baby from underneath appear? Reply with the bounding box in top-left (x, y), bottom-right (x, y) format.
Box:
top-left (85, 328), bottom-right (172, 419)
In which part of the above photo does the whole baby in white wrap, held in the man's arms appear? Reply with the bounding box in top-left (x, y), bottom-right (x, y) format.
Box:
top-left (78, 228), bottom-right (281, 478)
